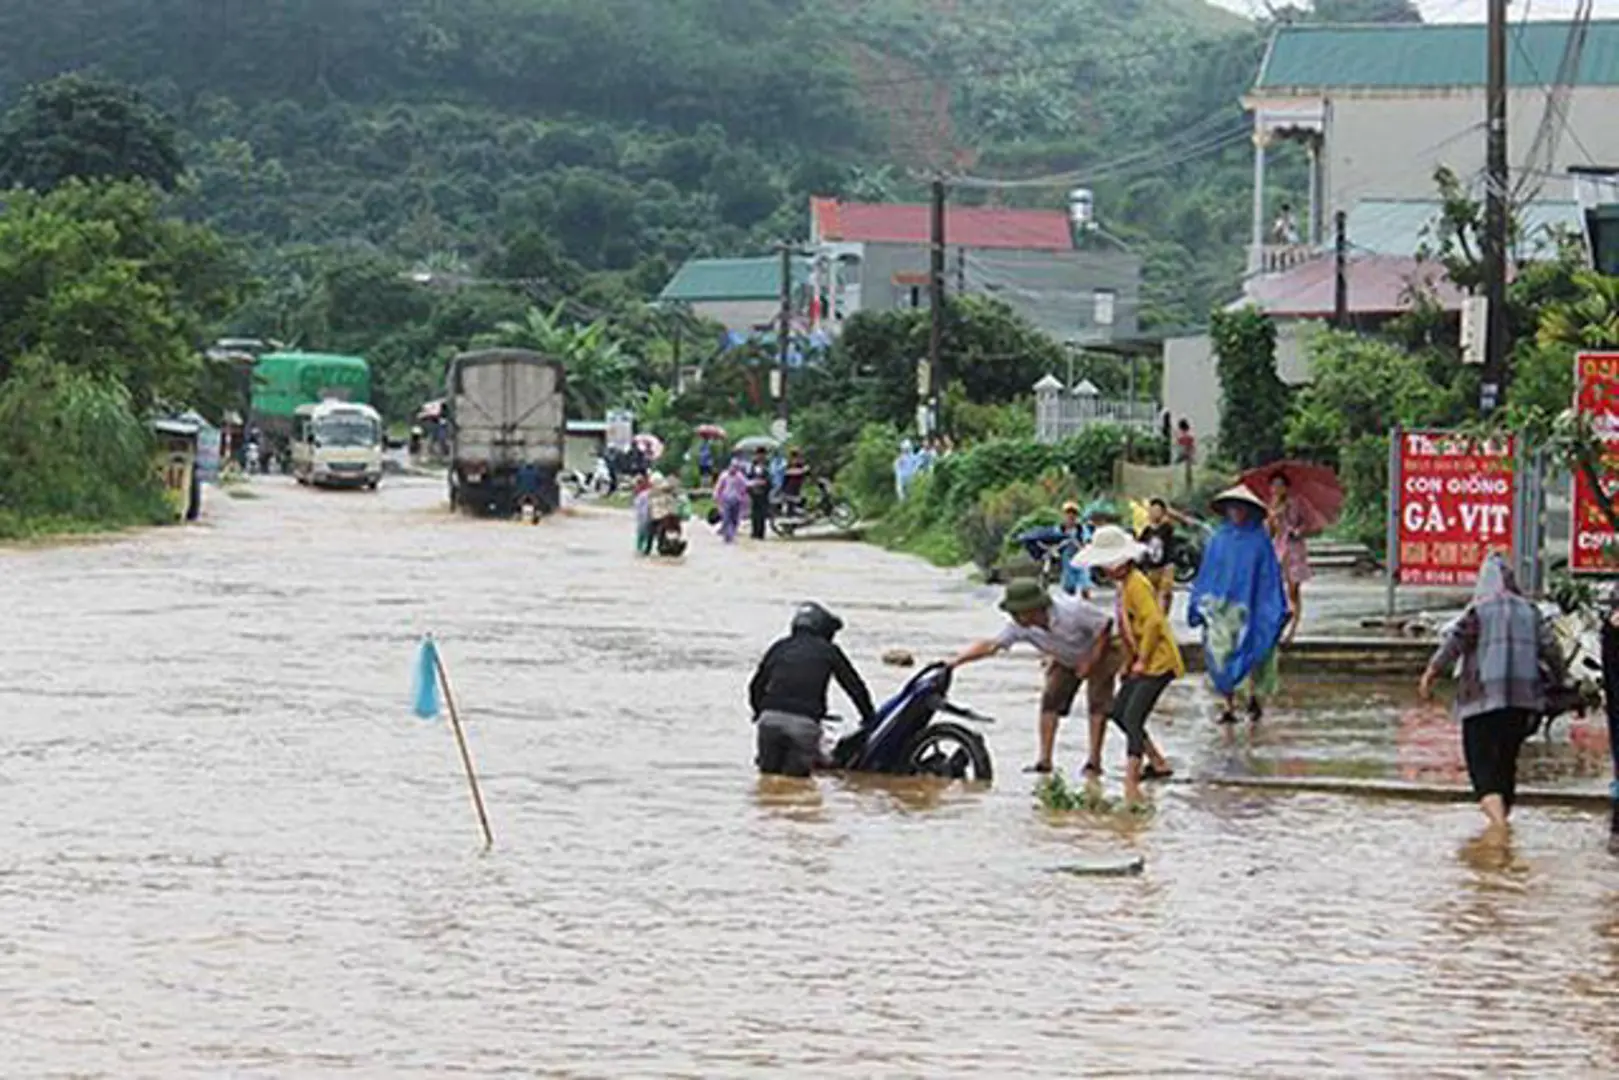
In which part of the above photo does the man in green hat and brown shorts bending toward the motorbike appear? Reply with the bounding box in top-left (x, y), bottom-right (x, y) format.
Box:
top-left (947, 581), bottom-right (1119, 776)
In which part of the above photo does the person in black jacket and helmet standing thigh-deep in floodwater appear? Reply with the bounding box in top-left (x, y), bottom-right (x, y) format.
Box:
top-left (748, 602), bottom-right (876, 776)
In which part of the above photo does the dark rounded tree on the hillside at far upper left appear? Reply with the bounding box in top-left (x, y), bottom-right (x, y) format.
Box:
top-left (0, 74), bottom-right (185, 191)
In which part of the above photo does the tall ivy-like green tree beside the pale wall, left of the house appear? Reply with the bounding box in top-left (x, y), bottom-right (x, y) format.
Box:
top-left (1209, 308), bottom-right (1289, 468)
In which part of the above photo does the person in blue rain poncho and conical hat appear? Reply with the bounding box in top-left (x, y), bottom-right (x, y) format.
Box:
top-left (1187, 484), bottom-right (1287, 724)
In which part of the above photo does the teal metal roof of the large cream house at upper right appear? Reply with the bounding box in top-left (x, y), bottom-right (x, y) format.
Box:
top-left (1253, 21), bottom-right (1619, 91)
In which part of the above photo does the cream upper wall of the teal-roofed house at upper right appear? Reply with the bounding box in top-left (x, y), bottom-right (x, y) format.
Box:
top-left (1323, 86), bottom-right (1619, 213)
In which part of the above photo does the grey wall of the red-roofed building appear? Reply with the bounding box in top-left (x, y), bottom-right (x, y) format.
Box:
top-left (860, 244), bottom-right (1141, 340)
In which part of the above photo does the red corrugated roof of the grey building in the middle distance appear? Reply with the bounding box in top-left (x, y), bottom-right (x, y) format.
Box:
top-left (810, 199), bottom-right (1073, 251)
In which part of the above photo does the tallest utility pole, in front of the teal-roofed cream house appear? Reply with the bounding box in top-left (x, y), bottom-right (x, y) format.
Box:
top-left (1478, 0), bottom-right (1507, 416)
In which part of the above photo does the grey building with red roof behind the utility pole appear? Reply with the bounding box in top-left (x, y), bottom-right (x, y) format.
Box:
top-left (810, 198), bottom-right (1141, 343)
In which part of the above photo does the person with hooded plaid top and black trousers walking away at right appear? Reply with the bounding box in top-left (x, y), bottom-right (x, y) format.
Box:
top-left (1418, 554), bottom-right (1562, 842)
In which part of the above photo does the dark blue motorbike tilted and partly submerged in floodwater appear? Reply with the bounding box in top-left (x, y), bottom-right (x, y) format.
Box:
top-left (826, 664), bottom-right (994, 784)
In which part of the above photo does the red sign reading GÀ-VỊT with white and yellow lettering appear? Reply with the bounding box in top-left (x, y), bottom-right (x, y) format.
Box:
top-left (1399, 431), bottom-right (1517, 585)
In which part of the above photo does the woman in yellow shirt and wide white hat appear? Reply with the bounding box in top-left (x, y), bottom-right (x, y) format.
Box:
top-left (1073, 525), bottom-right (1187, 803)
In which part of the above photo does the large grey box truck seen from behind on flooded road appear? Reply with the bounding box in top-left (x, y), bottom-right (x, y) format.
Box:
top-left (444, 348), bottom-right (567, 517)
